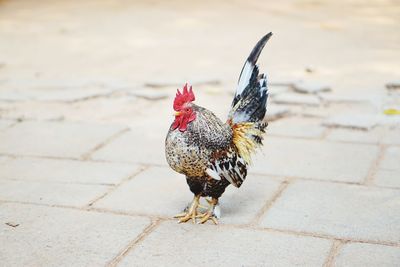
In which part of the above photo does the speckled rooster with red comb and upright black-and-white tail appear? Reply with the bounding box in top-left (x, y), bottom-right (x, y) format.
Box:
top-left (165, 33), bottom-right (272, 224)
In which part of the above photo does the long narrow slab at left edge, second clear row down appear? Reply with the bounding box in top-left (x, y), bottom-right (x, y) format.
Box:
top-left (0, 157), bottom-right (139, 185)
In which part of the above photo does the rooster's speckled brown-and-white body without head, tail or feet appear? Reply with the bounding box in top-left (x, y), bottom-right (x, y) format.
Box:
top-left (165, 104), bottom-right (238, 198)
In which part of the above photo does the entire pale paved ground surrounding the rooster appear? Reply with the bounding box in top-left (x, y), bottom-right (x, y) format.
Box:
top-left (0, 1), bottom-right (400, 266)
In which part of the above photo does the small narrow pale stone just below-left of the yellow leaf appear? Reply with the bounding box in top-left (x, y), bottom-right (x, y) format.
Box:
top-left (322, 114), bottom-right (378, 131)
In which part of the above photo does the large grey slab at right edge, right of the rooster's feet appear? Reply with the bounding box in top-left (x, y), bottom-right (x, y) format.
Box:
top-left (261, 181), bottom-right (400, 243)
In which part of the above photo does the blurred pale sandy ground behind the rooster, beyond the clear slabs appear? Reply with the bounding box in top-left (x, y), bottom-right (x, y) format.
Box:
top-left (0, 0), bottom-right (400, 130)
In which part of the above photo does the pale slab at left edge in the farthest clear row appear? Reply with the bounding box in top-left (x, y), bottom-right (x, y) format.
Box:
top-left (0, 121), bottom-right (125, 158)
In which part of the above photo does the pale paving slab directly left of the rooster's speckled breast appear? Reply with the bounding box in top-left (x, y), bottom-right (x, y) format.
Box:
top-left (91, 128), bottom-right (168, 165)
